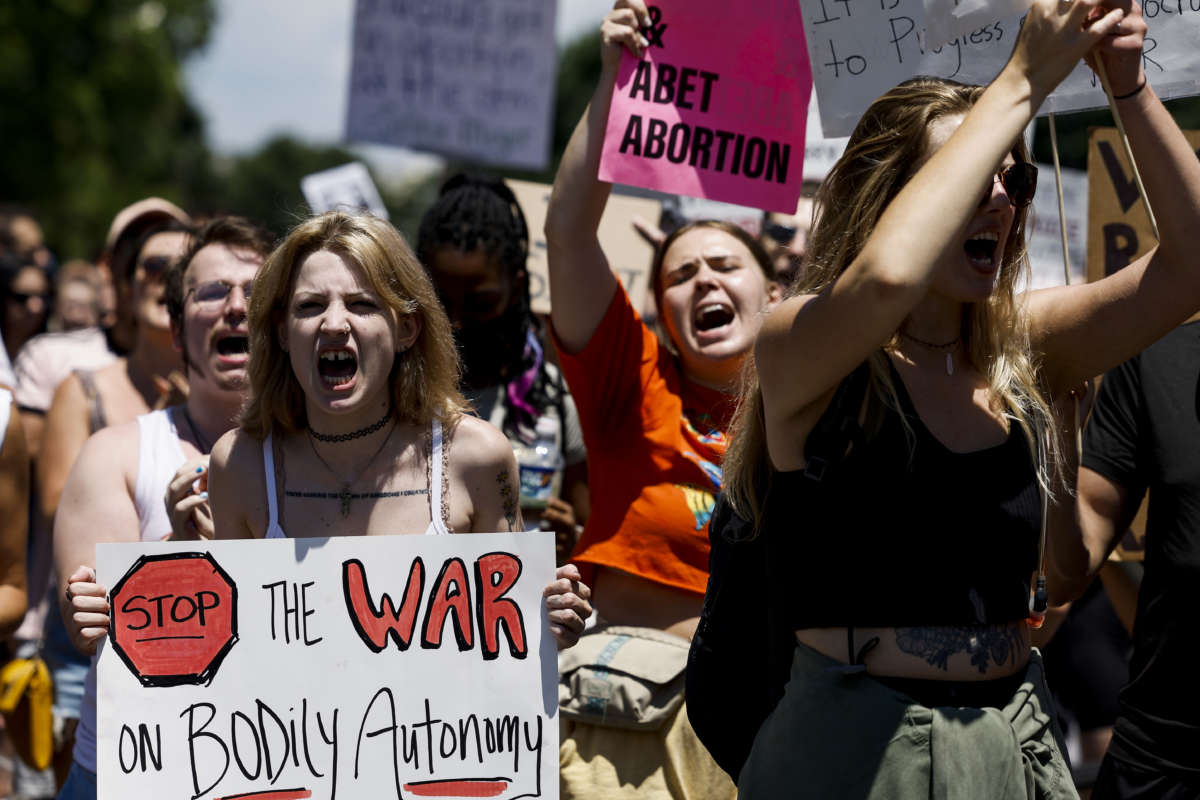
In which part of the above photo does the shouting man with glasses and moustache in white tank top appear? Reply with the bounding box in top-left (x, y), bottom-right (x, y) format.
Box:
top-left (54, 218), bottom-right (270, 800)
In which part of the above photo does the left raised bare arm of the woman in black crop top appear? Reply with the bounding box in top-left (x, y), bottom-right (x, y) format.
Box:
top-left (755, 0), bottom-right (1123, 455)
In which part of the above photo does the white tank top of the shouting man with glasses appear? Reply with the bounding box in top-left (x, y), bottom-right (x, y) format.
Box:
top-left (74, 409), bottom-right (187, 772)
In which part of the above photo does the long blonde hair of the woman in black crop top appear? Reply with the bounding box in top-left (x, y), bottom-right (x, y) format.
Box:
top-left (724, 78), bottom-right (1060, 531)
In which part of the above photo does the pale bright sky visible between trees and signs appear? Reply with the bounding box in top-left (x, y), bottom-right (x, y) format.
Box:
top-left (185, 0), bottom-right (612, 172)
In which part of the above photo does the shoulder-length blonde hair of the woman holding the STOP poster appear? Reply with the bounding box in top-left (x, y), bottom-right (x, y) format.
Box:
top-left (241, 211), bottom-right (467, 440)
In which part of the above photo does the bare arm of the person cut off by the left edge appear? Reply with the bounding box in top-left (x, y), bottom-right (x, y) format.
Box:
top-left (0, 404), bottom-right (29, 638)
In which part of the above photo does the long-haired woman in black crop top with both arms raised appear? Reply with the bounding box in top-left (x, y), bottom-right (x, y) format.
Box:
top-left (725, 0), bottom-right (1200, 800)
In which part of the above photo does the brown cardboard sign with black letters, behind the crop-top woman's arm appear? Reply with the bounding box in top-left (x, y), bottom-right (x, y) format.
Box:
top-left (1087, 125), bottom-right (1200, 281)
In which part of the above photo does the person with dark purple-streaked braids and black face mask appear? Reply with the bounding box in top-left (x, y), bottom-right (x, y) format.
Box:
top-left (416, 173), bottom-right (588, 564)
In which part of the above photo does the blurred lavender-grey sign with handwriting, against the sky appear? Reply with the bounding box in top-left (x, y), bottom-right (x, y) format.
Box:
top-left (346, 0), bottom-right (556, 169)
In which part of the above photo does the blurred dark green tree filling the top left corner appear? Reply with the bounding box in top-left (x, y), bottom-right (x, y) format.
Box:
top-left (0, 0), bottom-right (215, 258)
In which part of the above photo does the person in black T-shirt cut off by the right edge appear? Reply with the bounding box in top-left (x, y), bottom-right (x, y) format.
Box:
top-left (1075, 323), bottom-right (1200, 800)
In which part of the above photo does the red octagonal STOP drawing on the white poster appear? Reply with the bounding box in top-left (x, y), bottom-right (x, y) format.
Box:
top-left (109, 553), bottom-right (238, 686)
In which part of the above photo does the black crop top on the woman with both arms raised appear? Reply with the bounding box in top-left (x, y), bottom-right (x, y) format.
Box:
top-left (764, 360), bottom-right (1042, 630)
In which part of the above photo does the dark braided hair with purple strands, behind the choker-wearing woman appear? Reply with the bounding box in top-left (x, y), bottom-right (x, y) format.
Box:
top-left (416, 173), bottom-right (563, 438)
